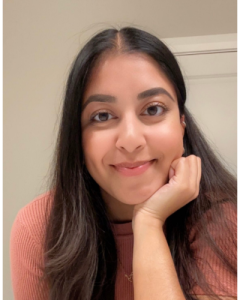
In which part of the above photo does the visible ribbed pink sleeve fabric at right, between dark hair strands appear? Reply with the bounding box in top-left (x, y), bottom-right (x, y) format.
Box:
top-left (188, 204), bottom-right (237, 297)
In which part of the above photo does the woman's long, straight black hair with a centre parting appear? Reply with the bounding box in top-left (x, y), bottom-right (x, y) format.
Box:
top-left (41, 27), bottom-right (237, 300)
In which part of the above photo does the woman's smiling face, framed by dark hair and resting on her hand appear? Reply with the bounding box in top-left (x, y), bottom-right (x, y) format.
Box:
top-left (81, 54), bottom-right (184, 221)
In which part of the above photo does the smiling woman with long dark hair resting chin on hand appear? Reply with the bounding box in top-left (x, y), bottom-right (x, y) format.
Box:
top-left (11, 27), bottom-right (237, 300)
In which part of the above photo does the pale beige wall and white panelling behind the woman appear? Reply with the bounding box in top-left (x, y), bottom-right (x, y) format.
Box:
top-left (3, 0), bottom-right (236, 300)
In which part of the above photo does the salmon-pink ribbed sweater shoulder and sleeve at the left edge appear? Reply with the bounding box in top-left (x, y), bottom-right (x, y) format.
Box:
top-left (10, 192), bottom-right (53, 299)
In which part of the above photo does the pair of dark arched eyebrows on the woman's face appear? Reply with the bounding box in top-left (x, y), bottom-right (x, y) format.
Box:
top-left (82, 87), bottom-right (174, 111)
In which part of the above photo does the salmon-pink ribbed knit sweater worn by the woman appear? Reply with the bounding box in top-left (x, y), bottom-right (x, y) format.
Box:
top-left (10, 193), bottom-right (237, 300)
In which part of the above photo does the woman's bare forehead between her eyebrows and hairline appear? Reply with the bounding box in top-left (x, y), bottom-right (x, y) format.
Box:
top-left (84, 53), bottom-right (176, 100)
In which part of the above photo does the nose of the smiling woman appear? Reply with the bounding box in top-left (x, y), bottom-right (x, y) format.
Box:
top-left (116, 115), bottom-right (146, 153)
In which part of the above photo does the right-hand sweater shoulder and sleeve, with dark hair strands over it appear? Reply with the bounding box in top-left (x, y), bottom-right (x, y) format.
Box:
top-left (188, 202), bottom-right (237, 299)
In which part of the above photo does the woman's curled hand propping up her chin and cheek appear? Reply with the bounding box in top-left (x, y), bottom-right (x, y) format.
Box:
top-left (133, 155), bottom-right (201, 225)
